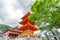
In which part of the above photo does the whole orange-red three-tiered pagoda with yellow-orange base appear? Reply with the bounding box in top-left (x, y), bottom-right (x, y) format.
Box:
top-left (17, 12), bottom-right (39, 37)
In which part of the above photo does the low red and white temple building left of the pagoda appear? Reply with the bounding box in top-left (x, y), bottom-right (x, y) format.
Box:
top-left (3, 27), bottom-right (22, 38)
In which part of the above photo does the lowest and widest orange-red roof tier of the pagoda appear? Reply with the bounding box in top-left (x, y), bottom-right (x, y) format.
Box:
top-left (17, 23), bottom-right (39, 31)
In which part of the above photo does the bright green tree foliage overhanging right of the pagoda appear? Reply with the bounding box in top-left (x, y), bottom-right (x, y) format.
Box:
top-left (28, 0), bottom-right (60, 29)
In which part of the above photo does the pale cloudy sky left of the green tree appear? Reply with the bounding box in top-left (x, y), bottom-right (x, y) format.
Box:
top-left (0, 0), bottom-right (33, 27)
